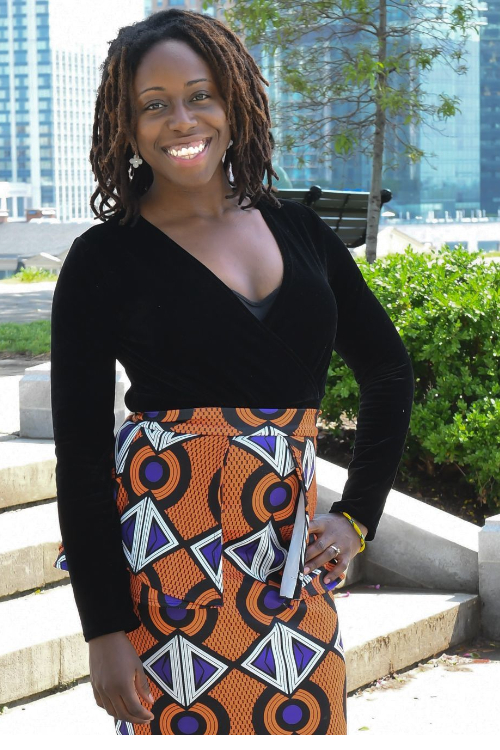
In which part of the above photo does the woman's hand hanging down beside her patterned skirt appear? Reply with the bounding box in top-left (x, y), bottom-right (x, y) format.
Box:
top-left (89, 630), bottom-right (154, 724)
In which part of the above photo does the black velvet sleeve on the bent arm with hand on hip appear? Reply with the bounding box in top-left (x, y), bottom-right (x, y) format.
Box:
top-left (316, 212), bottom-right (415, 541)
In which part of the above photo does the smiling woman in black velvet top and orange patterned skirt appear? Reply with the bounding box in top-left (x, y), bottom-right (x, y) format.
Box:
top-left (52, 10), bottom-right (413, 734)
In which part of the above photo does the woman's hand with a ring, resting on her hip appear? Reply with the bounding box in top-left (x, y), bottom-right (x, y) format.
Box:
top-left (304, 513), bottom-right (367, 583)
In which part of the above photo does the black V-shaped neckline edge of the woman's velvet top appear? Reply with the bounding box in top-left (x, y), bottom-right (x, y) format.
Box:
top-left (139, 198), bottom-right (292, 326)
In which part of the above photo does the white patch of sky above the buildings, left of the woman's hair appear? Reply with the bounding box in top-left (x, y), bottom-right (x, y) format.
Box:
top-left (49, 0), bottom-right (144, 59)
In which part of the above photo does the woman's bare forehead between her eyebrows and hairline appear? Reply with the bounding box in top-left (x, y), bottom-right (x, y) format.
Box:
top-left (134, 39), bottom-right (213, 96)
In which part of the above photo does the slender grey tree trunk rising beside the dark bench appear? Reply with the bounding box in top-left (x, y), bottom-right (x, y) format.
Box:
top-left (366, 0), bottom-right (387, 263)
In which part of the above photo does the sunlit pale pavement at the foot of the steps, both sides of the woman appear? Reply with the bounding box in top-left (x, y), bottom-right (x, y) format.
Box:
top-left (0, 643), bottom-right (500, 742)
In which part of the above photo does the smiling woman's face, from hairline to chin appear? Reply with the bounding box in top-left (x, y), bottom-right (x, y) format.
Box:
top-left (134, 39), bottom-right (231, 188)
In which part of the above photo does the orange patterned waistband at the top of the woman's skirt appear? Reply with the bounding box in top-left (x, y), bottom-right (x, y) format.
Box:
top-left (125, 406), bottom-right (321, 437)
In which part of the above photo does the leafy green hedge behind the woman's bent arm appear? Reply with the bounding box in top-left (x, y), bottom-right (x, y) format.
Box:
top-left (321, 245), bottom-right (500, 509)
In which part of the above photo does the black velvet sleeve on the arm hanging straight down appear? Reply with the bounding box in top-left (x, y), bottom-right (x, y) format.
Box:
top-left (51, 237), bottom-right (140, 642)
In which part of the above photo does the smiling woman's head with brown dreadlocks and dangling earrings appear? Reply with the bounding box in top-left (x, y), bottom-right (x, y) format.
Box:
top-left (91, 9), bottom-right (277, 223)
